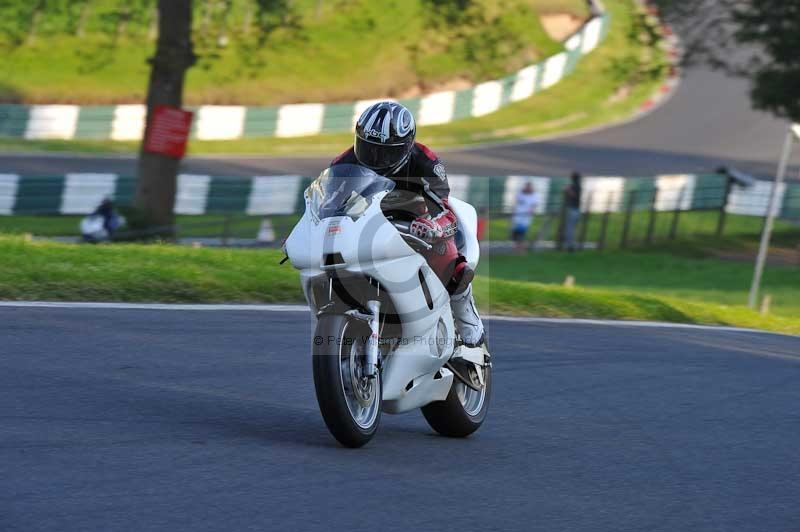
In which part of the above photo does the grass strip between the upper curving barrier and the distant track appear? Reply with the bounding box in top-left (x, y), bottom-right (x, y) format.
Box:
top-left (0, 0), bottom-right (667, 154)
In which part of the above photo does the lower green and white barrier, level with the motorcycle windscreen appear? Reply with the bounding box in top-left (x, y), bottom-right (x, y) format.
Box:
top-left (0, 173), bottom-right (800, 219)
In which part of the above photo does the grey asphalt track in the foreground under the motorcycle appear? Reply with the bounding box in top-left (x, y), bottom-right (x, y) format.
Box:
top-left (0, 308), bottom-right (800, 532)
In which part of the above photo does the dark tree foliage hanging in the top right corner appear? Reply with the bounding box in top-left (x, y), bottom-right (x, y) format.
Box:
top-left (657, 0), bottom-right (800, 122)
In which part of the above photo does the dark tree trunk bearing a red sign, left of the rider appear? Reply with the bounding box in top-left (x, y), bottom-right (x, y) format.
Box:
top-left (134, 0), bottom-right (196, 235)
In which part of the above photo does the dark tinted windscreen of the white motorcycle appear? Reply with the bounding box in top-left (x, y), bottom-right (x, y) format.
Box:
top-left (308, 164), bottom-right (394, 220)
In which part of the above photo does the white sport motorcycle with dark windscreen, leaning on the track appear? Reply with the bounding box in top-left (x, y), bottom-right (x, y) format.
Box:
top-left (285, 165), bottom-right (492, 447)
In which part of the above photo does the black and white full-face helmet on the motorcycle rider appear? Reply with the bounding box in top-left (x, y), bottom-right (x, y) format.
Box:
top-left (354, 102), bottom-right (417, 176)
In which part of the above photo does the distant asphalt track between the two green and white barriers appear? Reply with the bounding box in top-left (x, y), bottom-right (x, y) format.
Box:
top-left (0, 63), bottom-right (800, 179)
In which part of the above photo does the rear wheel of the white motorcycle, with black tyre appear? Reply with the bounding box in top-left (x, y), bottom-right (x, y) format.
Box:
top-left (422, 358), bottom-right (492, 438)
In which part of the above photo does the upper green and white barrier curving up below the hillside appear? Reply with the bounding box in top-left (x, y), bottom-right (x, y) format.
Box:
top-left (0, 14), bottom-right (610, 141)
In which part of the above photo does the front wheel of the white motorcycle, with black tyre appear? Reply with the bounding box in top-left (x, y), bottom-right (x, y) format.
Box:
top-left (313, 315), bottom-right (382, 447)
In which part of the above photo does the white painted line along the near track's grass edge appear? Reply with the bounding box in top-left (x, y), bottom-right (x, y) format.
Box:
top-left (0, 301), bottom-right (795, 337)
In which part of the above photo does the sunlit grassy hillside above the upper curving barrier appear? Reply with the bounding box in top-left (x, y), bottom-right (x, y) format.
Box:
top-left (0, 0), bottom-right (588, 105)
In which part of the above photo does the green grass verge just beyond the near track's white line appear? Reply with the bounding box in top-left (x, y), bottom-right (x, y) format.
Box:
top-left (0, 236), bottom-right (800, 334)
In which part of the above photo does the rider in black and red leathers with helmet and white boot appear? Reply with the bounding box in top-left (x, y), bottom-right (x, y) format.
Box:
top-left (331, 102), bottom-right (485, 347)
